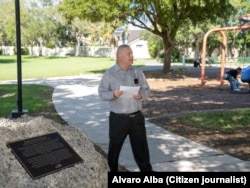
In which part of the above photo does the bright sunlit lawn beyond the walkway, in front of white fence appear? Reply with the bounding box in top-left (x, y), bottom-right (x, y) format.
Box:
top-left (0, 56), bottom-right (143, 80)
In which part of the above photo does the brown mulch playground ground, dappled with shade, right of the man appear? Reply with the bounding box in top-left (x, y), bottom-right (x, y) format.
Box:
top-left (143, 67), bottom-right (250, 160)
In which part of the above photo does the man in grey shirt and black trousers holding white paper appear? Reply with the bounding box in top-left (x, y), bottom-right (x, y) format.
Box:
top-left (98, 45), bottom-right (152, 172)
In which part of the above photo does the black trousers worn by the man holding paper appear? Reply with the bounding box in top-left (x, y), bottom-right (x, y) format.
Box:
top-left (108, 112), bottom-right (152, 172)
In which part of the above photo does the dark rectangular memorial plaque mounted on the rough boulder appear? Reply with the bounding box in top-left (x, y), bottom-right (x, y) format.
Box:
top-left (7, 132), bottom-right (83, 179)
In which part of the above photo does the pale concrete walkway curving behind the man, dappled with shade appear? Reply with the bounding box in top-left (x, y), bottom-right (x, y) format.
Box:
top-left (2, 62), bottom-right (250, 172)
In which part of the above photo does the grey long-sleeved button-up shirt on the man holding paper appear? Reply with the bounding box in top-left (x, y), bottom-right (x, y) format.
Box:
top-left (98, 64), bottom-right (150, 114)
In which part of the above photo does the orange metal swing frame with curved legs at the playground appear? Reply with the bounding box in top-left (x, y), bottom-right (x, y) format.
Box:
top-left (201, 14), bottom-right (250, 86)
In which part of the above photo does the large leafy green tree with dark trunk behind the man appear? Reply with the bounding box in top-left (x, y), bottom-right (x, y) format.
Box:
top-left (59, 0), bottom-right (234, 73)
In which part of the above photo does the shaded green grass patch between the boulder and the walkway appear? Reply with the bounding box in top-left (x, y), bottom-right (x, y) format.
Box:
top-left (0, 84), bottom-right (65, 124)
